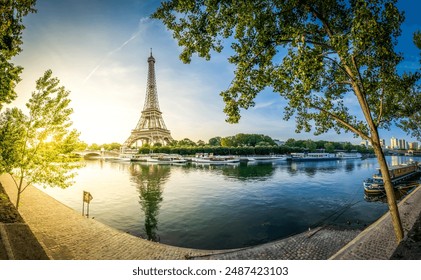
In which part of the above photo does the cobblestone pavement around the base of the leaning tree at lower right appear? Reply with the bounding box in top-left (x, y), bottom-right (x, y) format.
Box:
top-left (330, 187), bottom-right (421, 260)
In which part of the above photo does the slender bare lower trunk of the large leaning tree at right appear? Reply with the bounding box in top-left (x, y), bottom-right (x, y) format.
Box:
top-left (372, 133), bottom-right (403, 243)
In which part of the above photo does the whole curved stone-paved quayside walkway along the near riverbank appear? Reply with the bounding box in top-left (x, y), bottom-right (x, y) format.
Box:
top-left (0, 175), bottom-right (421, 260)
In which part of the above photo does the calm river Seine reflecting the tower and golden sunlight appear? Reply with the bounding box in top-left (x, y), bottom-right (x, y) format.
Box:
top-left (37, 157), bottom-right (416, 249)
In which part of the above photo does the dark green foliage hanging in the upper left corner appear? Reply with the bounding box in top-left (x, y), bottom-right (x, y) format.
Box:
top-left (0, 0), bottom-right (35, 110)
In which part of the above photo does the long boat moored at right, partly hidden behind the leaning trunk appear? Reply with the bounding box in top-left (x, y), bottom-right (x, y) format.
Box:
top-left (363, 161), bottom-right (421, 194)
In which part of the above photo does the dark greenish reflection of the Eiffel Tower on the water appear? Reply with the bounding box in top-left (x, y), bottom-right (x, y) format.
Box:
top-left (129, 164), bottom-right (171, 241)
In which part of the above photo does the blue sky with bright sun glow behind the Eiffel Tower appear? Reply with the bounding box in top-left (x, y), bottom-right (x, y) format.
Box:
top-left (9, 0), bottom-right (421, 143)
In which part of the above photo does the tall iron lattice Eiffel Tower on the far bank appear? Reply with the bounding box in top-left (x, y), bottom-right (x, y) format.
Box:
top-left (123, 49), bottom-right (173, 148)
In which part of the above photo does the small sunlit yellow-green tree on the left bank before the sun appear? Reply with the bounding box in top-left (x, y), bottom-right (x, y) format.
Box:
top-left (0, 70), bottom-right (81, 208)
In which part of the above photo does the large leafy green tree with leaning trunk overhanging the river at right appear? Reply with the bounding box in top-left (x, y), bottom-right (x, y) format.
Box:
top-left (152, 0), bottom-right (421, 241)
